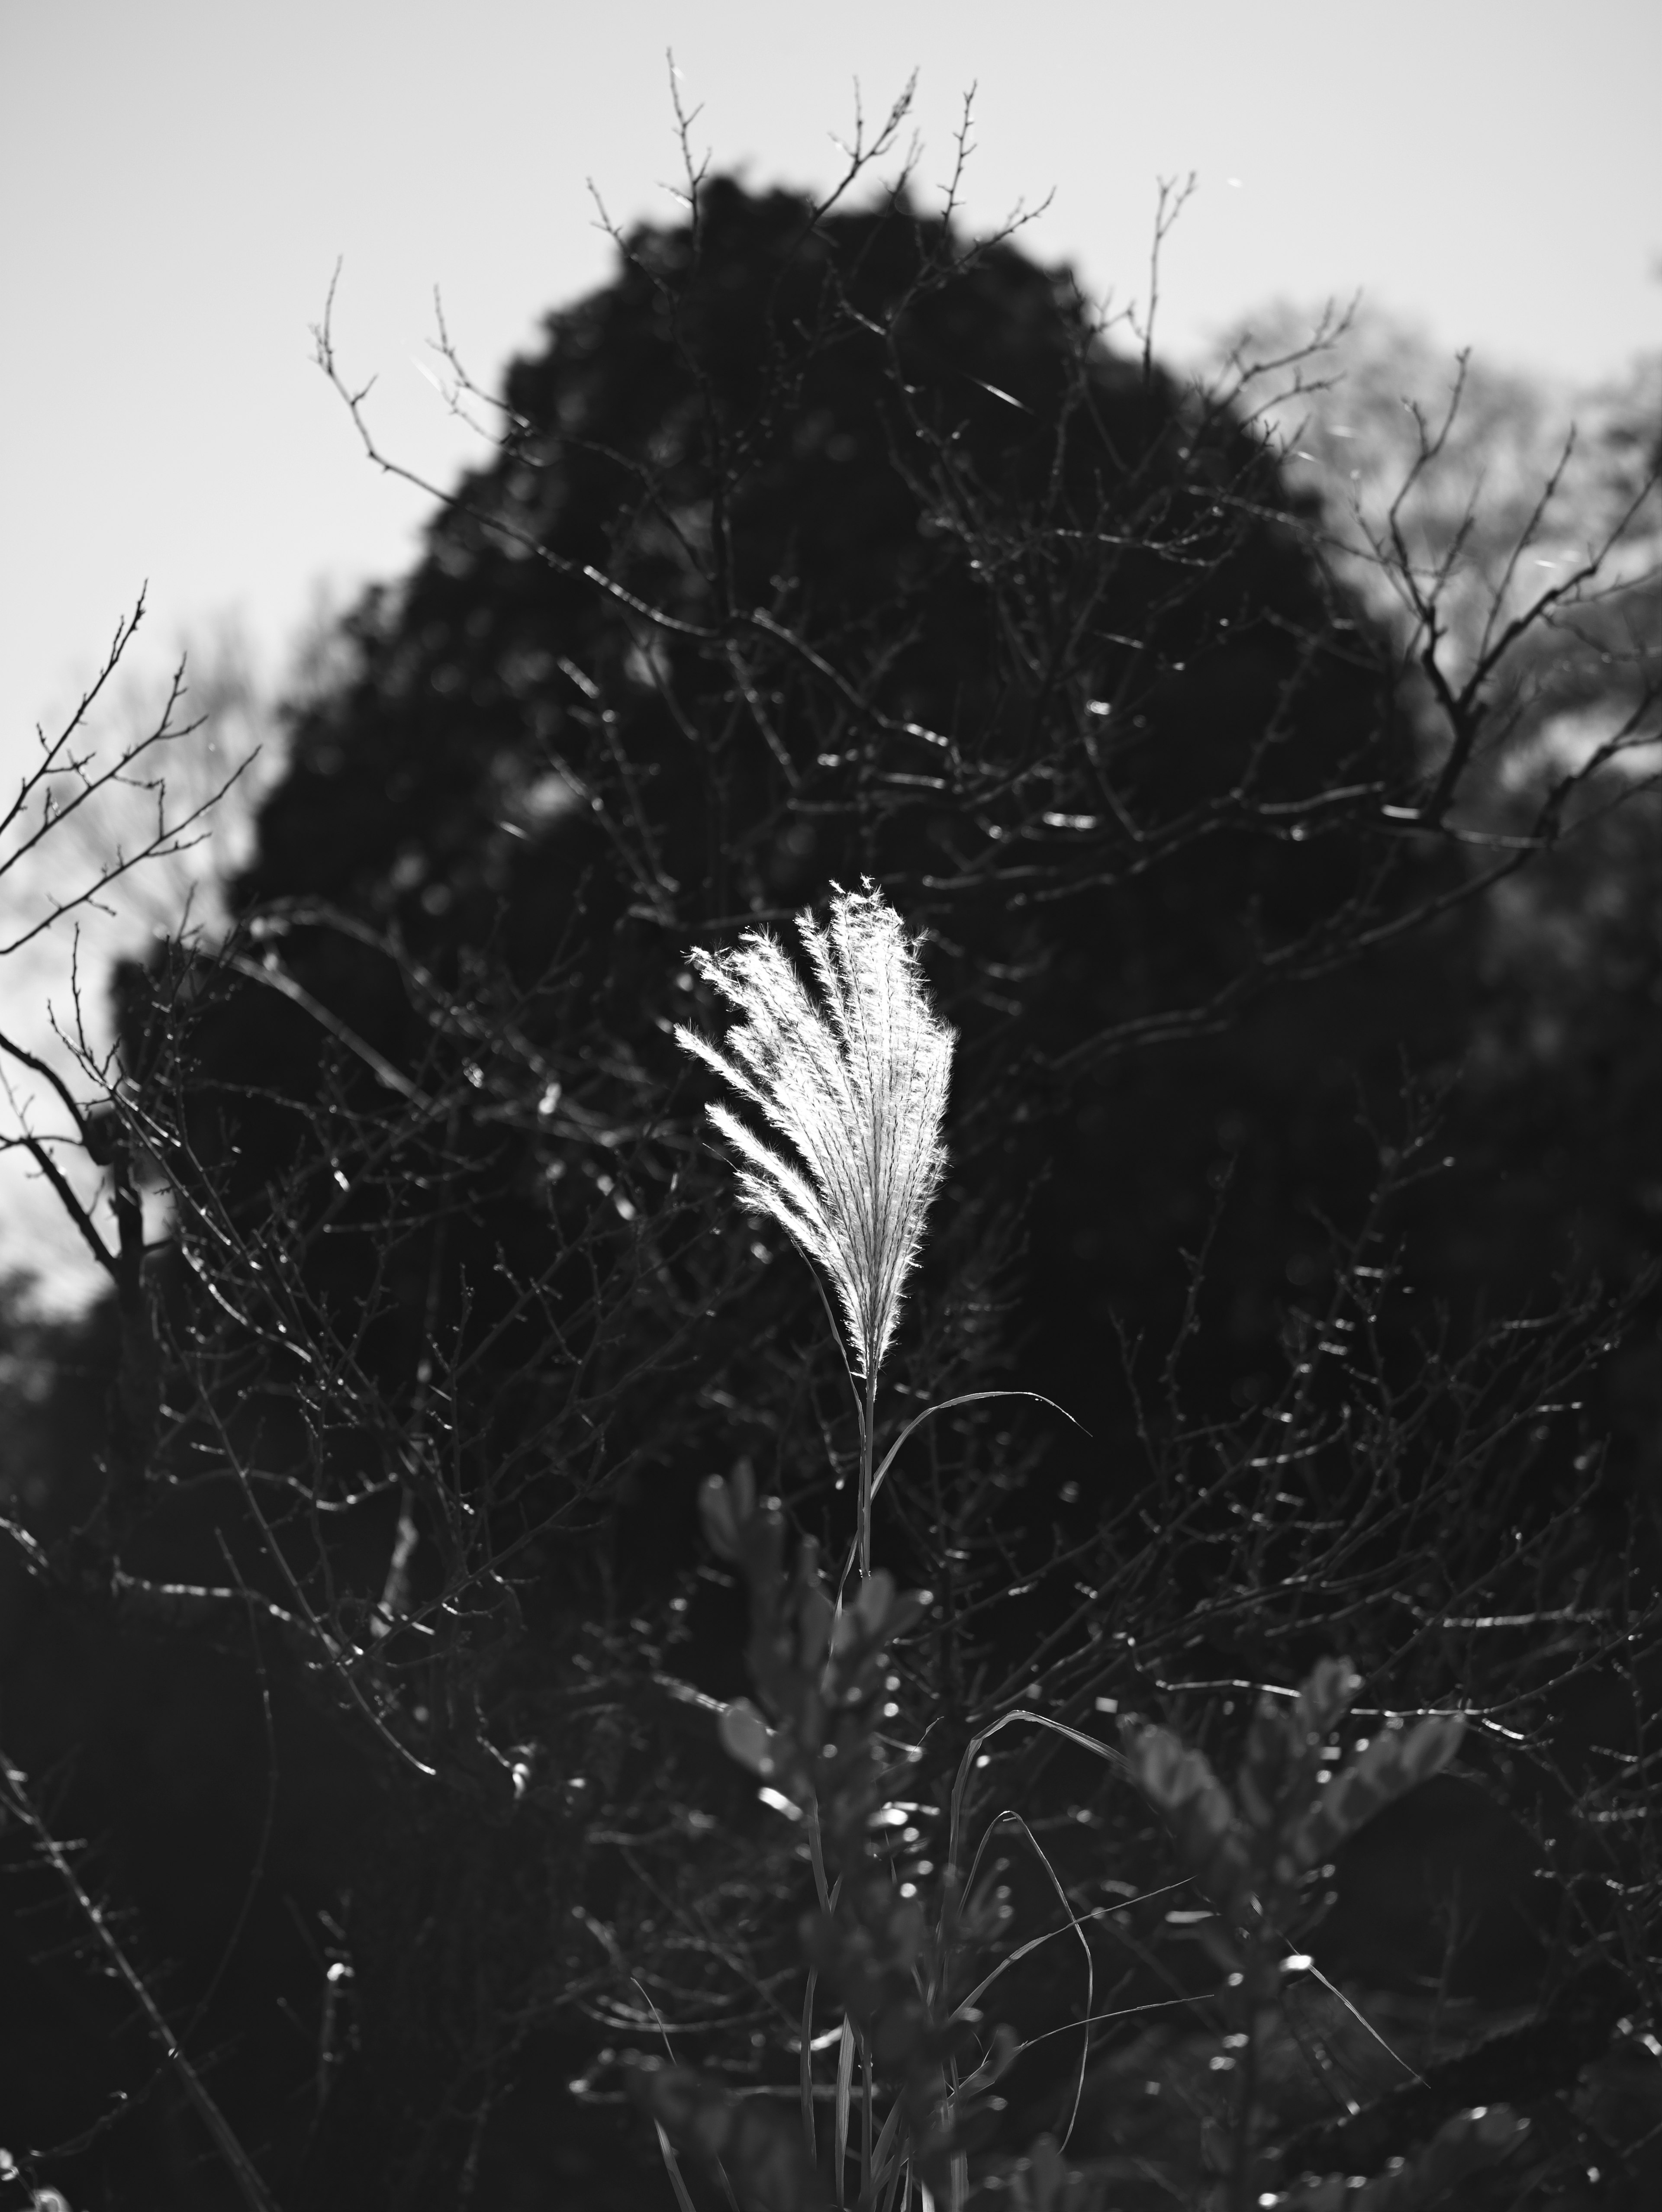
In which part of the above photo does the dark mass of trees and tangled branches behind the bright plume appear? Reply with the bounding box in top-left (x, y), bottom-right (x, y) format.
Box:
top-left (0, 129), bottom-right (1662, 2212)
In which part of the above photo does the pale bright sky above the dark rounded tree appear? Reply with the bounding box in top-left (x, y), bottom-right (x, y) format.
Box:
top-left (0, 0), bottom-right (1662, 1300)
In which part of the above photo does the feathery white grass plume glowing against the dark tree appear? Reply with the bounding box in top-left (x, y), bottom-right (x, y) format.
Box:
top-left (675, 883), bottom-right (956, 1389)
